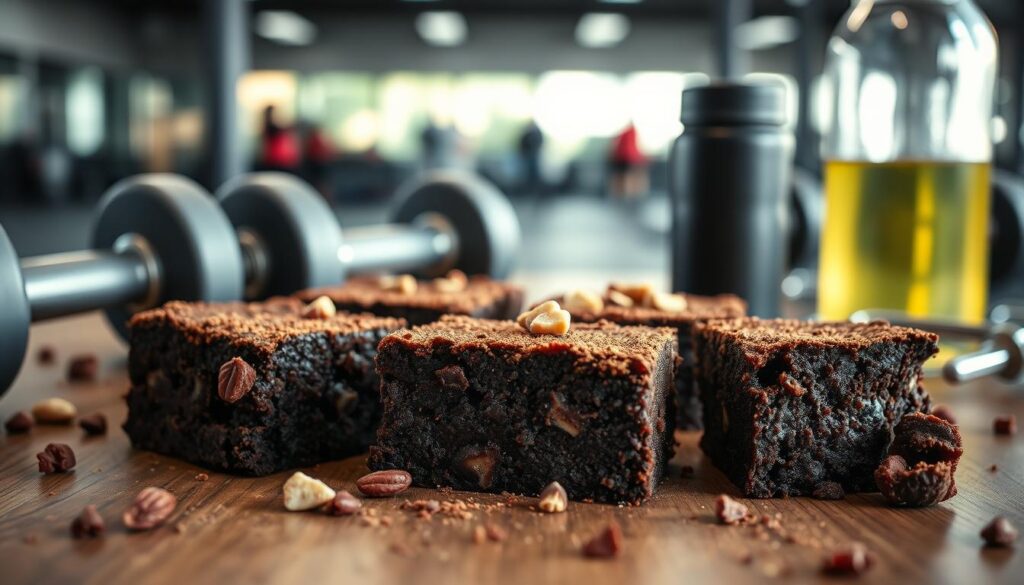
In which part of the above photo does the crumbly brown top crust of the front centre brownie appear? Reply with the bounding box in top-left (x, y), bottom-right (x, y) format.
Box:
top-left (380, 315), bottom-right (676, 372)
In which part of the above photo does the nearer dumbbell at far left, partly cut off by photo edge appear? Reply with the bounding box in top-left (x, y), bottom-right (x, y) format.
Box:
top-left (0, 174), bottom-right (245, 394)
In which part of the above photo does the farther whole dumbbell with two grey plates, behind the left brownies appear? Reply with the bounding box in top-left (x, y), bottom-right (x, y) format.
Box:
top-left (216, 171), bottom-right (519, 299)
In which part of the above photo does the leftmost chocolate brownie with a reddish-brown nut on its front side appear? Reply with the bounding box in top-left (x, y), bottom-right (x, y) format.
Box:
top-left (124, 299), bottom-right (403, 475)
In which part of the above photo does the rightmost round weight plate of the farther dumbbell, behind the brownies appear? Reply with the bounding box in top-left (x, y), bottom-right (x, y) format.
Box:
top-left (393, 171), bottom-right (519, 279)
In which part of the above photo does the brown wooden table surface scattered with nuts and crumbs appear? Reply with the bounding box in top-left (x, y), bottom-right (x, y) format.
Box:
top-left (0, 315), bottom-right (1024, 585)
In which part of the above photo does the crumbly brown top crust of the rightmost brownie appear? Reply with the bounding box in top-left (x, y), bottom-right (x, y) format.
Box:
top-left (696, 317), bottom-right (939, 354)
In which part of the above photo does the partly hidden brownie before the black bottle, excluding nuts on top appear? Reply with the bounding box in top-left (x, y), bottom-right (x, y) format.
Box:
top-left (554, 292), bottom-right (746, 430)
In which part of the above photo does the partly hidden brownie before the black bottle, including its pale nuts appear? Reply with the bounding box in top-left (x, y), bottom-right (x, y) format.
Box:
top-left (540, 284), bottom-right (746, 430)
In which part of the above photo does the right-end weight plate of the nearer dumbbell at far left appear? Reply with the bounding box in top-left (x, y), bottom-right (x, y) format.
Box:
top-left (92, 174), bottom-right (245, 337)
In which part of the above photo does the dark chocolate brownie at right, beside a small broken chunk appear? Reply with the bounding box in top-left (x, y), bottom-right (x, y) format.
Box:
top-left (693, 318), bottom-right (938, 498)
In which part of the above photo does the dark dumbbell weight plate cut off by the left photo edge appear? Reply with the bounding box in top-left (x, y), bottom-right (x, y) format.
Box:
top-left (0, 226), bottom-right (32, 395)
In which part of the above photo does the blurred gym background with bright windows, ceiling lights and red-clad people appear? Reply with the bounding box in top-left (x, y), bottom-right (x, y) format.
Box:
top-left (0, 0), bottom-right (1024, 284)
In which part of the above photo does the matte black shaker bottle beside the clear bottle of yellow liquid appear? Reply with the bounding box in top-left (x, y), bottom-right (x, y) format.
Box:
top-left (669, 83), bottom-right (794, 317)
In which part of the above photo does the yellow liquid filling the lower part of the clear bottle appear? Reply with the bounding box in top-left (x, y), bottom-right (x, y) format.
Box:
top-left (818, 161), bottom-right (990, 323)
